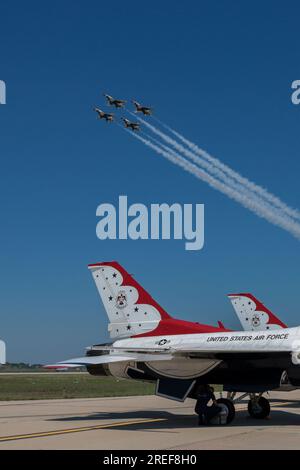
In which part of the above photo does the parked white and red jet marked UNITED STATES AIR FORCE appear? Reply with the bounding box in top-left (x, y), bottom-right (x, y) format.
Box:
top-left (47, 262), bottom-right (300, 418)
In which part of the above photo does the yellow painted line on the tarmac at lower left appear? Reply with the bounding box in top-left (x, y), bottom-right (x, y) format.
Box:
top-left (0, 418), bottom-right (167, 442)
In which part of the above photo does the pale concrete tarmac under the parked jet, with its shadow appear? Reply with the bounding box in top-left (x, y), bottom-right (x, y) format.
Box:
top-left (0, 390), bottom-right (300, 450)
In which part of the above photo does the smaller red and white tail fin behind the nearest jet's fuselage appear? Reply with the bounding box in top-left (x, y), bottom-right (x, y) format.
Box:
top-left (228, 294), bottom-right (287, 331)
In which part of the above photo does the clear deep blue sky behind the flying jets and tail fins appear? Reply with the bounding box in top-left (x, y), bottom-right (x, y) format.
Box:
top-left (0, 0), bottom-right (300, 362)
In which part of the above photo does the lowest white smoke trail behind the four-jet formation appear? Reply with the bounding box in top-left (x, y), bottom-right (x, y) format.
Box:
top-left (125, 129), bottom-right (300, 239)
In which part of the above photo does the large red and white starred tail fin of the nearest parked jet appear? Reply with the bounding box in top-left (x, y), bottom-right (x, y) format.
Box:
top-left (89, 261), bottom-right (171, 338)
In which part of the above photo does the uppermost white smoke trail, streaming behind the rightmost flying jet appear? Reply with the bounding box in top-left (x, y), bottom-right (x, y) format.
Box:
top-left (152, 116), bottom-right (300, 220)
